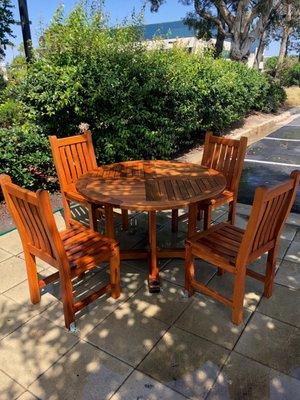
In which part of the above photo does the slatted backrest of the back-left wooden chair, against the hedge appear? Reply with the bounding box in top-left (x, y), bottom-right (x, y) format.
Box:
top-left (49, 131), bottom-right (97, 190)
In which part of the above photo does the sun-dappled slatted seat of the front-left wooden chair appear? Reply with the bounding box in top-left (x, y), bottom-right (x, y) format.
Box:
top-left (60, 223), bottom-right (118, 268)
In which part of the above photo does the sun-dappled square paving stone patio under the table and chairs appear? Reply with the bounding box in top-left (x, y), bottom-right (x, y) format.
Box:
top-left (0, 204), bottom-right (300, 400)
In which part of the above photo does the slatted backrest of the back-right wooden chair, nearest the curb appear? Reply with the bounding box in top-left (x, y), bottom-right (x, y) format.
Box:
top-left (201, 132), bottom-right (247, 194)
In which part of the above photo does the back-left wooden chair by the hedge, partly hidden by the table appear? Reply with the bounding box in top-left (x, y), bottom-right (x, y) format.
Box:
top-left (49, 131), bottom-right (128, 231)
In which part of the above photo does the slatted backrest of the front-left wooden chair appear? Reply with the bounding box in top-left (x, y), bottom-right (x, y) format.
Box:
top-left (0, 175), bottom-right (65, 267)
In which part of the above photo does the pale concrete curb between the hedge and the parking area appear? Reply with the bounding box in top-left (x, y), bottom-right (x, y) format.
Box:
top-left (176, 107), bottom-right (300, 164)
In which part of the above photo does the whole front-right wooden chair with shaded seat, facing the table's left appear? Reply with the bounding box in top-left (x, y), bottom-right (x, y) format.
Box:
top-left (185, 171), bottom-right (300, 324)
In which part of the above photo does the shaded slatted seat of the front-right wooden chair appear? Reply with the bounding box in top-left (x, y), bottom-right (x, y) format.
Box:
top-left (186, 222), bottom-right (245, 266)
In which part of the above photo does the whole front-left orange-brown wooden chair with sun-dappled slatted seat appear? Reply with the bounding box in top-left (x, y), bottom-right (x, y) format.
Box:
top-left (0, 175), bottom-right (120, 329)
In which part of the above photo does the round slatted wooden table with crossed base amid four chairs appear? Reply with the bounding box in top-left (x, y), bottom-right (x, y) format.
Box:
top-left (76, 161), bottom-right (226, 292)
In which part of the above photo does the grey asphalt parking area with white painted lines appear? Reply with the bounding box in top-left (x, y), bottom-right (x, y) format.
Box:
top-left (238, 117), bottom-right (300, 213)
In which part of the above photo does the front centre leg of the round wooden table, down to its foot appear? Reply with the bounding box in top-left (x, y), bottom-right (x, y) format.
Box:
top-left (148, 211), bottom-right (160, 293)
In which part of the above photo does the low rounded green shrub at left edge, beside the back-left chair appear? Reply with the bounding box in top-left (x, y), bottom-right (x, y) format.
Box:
top-left (0, 128), bottom-right (55, 189)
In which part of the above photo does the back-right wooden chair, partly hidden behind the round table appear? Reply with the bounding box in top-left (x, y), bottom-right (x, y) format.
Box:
top-left (172, 132), bottom-right (247, 232)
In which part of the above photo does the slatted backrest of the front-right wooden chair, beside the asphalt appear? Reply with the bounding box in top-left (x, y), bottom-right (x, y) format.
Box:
top-left (238, 171), bottom-right (300, 260)
